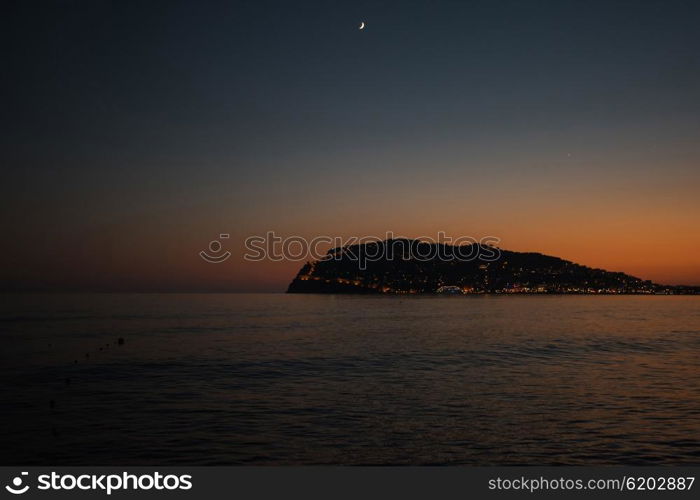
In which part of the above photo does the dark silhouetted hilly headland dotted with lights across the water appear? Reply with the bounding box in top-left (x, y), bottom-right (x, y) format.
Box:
top-left (287, 239), bottom-right (700, 295)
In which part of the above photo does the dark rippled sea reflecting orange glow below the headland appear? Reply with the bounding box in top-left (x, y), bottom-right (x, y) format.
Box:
top-left (0, 294), bottom-right (700, 465)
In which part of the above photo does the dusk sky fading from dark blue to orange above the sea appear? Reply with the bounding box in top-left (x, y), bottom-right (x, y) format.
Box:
top-left (0, 0), bottom-right (700, 291)
